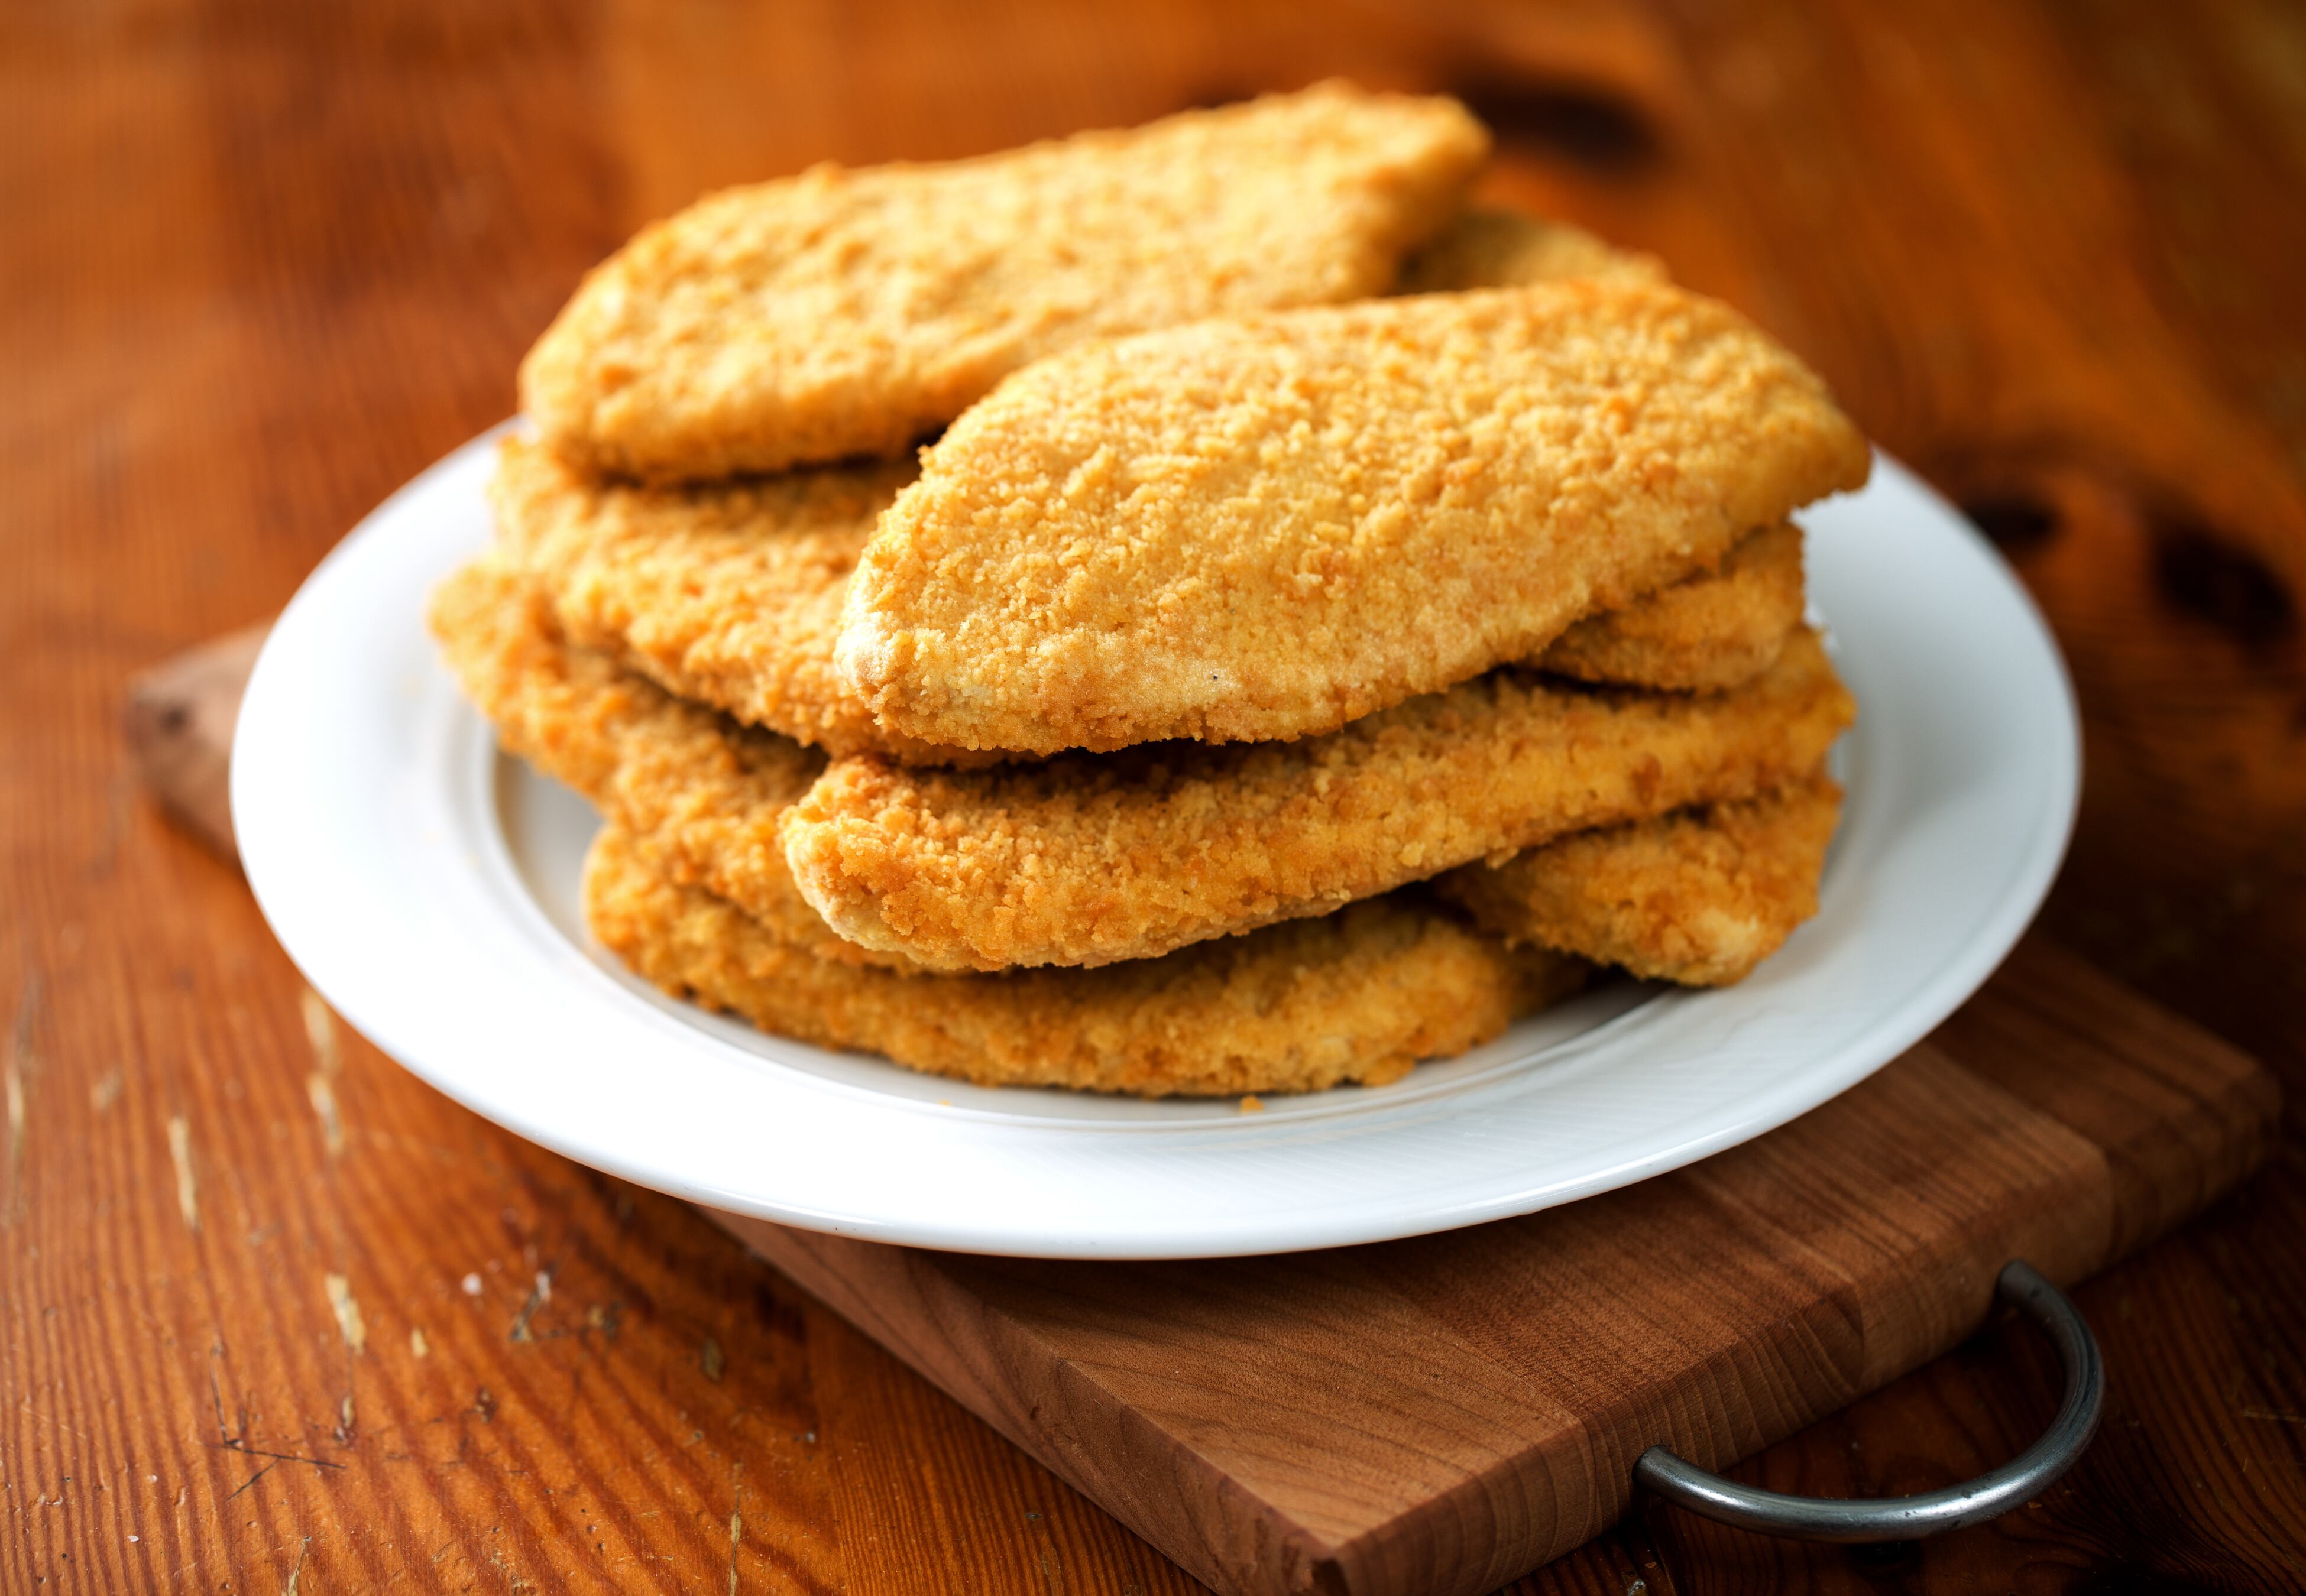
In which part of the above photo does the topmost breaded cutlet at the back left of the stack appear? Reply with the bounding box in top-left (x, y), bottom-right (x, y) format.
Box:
top-left (521, 83), bottom-right (1489, 480)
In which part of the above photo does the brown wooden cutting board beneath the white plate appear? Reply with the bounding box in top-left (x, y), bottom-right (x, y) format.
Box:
top-left (127, 630), bottom-right (2281, 1596)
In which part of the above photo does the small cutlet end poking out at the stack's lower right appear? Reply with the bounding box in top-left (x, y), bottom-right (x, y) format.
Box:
top-left (1434, 770), bottom-right (1842, 987)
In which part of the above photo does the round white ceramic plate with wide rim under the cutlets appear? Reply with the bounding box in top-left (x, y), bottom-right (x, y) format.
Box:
top-left (233, 424), bottom-right (2080, 1257)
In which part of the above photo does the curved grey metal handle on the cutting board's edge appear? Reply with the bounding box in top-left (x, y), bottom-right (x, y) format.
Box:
top-left (1633, 1261), bottom-right (2106, 1543)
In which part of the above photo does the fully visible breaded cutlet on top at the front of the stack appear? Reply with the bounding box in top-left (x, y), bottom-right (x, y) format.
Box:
top-left (837, 281), bottom-right (1868, 754)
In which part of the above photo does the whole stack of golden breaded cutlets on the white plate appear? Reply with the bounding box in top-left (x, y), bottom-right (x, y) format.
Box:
top-left (433, 85), bottom-right (1868, 1095)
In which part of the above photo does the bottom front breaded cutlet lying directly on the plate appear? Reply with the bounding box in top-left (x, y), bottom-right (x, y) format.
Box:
top-left (584, 826), bottom-right (1589, 1098)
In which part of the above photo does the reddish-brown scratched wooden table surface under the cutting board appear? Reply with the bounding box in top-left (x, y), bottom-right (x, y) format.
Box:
top-left (0, 0), bottom-right (2306, 1596)
